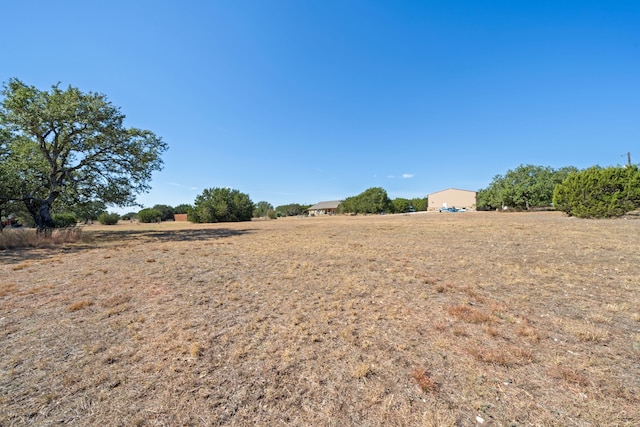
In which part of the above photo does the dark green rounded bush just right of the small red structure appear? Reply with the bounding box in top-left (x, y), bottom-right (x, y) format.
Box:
top-left (188, 188), bottom-right (254, 223)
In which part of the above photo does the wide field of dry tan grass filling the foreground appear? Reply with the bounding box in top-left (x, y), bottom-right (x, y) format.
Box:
top-left (0, 213), bottom-right (640, 426)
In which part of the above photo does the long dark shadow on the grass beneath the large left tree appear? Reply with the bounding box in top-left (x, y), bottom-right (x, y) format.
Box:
top-left (0, 228), bottom-right (253, 264)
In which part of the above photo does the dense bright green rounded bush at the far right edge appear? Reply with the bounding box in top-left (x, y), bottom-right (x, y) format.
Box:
top-left (553, 165), bottom-right (640, 218)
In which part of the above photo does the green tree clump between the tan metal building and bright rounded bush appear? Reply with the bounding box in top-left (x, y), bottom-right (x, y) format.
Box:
top-left (477, 165), bottom-right (577, 210)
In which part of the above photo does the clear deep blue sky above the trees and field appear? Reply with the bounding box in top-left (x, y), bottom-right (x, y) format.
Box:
top-left (0, 0), bottom-right (640, 211)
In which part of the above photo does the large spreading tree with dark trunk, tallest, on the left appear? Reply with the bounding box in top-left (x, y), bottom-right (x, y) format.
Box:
top-left (0, 79), bottom-right (167, 231)
